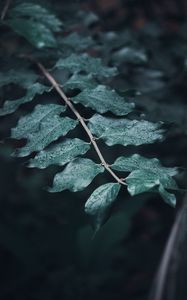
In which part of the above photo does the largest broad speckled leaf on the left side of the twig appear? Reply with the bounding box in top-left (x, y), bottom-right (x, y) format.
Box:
top-left (11, 104), bottom-right (78, 157)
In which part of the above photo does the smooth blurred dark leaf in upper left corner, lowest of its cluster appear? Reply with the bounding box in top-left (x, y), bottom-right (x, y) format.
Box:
top-left (6, 19), bottom-right (57, 48)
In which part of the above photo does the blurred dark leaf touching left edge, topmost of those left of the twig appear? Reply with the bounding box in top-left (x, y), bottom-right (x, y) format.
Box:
top-left (0, 69), bottom-right (38, 88)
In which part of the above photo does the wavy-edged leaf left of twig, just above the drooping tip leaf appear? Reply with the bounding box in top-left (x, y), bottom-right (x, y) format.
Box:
top-left (49, 158), bottom-right (104, 192)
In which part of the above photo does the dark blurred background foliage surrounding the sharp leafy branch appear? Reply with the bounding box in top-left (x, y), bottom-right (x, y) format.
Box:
top-left (0, 0), bottom-right (187, 300)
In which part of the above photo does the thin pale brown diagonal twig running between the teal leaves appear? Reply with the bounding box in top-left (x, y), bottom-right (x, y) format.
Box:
top-left (36, 62), bottom-right (127, 185)
